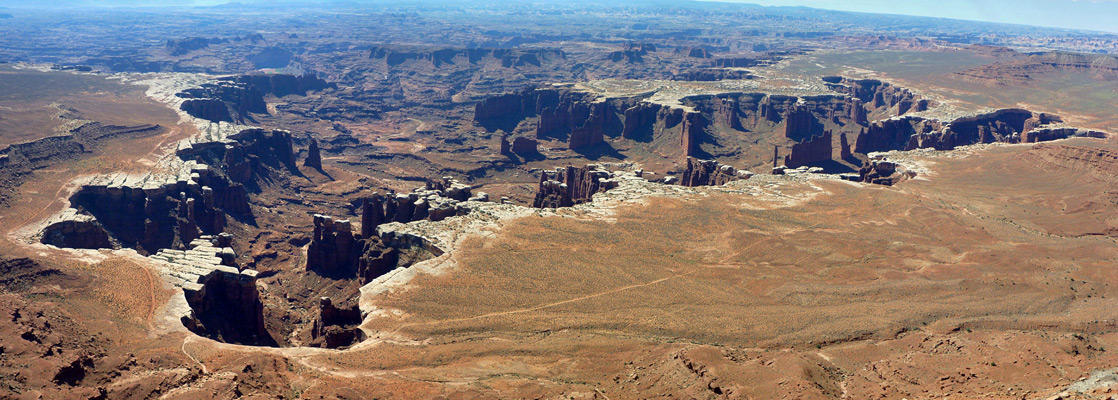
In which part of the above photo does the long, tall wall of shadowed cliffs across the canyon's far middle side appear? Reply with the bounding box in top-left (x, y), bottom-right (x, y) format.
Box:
top-left (474, 77), bottom-right (934, 164)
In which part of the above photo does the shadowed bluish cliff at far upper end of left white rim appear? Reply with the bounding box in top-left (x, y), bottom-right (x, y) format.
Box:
top-left (176, 74), bottom-right (337, 124)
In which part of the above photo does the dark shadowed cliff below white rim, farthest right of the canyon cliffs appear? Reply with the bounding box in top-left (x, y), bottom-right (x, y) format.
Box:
top-left (854, 108), bottom-right (1082, 154)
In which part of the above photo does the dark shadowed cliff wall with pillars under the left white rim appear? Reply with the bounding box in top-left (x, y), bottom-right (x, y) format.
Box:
top-left (51, 130), bottom-right (297, 254)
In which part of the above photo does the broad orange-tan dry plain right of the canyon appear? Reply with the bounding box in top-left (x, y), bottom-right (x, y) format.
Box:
top-left (366, 139), bottom-right (1118, 347)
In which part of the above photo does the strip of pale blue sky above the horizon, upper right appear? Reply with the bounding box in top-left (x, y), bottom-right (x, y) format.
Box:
top-left (716, 0), bottom-right (1118, 32)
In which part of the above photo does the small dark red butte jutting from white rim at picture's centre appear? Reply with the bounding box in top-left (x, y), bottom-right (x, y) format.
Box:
top-left (532, 164), bottom-right (617, 208)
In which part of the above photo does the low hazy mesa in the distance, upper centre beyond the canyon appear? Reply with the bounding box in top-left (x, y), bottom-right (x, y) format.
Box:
top-left (369, 45), bottom-right (567, 68)
